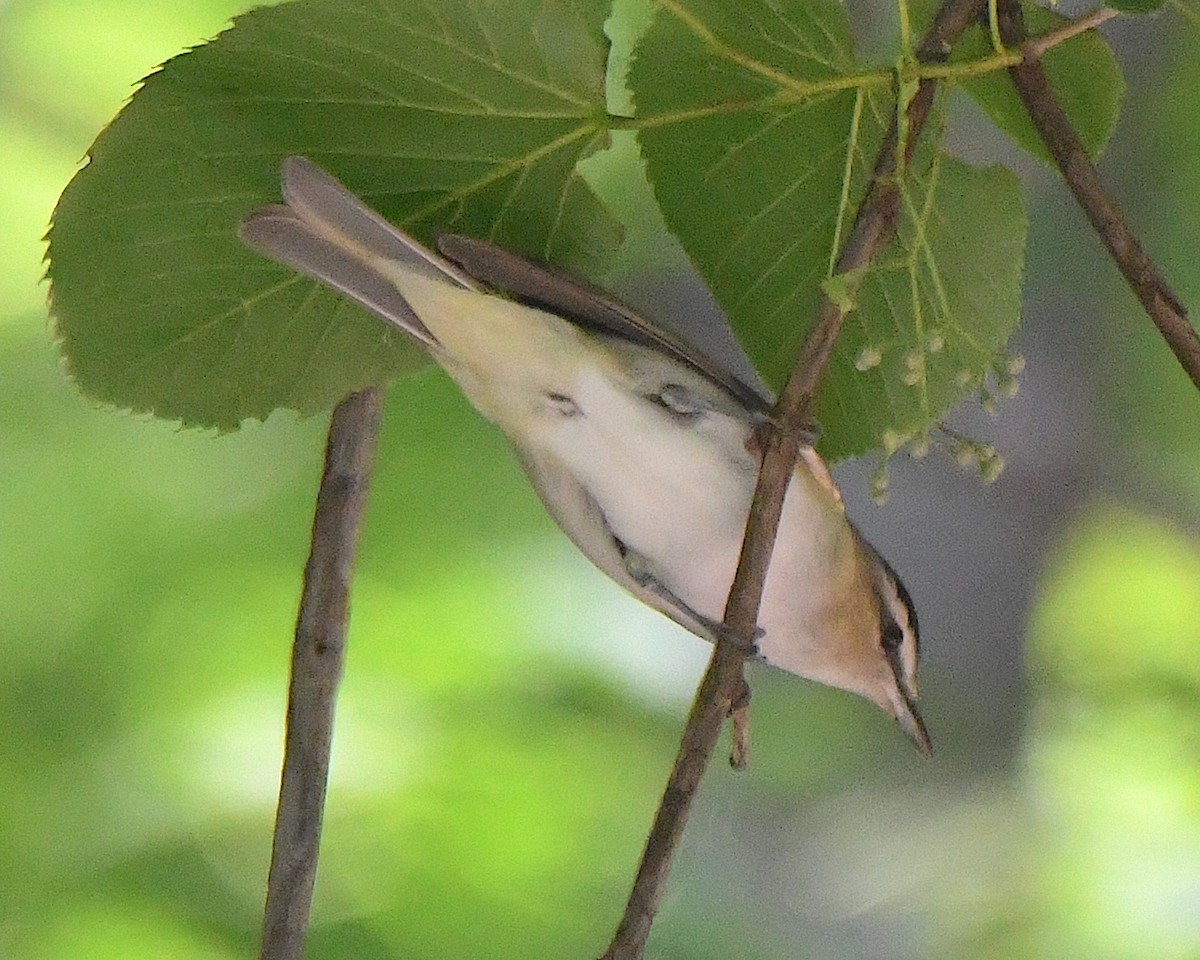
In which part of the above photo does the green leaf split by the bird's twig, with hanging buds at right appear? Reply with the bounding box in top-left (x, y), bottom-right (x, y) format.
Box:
top-left (630, 0), bottom-right (1025, 457)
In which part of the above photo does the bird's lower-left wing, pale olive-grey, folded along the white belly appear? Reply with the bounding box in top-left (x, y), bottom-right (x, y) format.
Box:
top-left (516, 448), bottom-right (713, 641)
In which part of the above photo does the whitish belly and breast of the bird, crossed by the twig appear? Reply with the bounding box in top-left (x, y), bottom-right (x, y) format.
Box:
top-left (539, 364), bottom-right (854, 676)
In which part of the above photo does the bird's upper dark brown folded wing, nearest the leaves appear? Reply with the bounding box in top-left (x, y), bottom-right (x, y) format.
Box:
top-left (438, 234), bottom-right (772, 414)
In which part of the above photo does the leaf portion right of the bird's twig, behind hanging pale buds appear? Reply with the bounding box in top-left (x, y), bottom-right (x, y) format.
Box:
top-left (849, 152), bottom-right (1027, 456)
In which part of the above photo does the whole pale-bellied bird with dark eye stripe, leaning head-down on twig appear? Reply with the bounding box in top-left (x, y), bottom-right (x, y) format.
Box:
top-left (239, 157), bottom-right (930, 752)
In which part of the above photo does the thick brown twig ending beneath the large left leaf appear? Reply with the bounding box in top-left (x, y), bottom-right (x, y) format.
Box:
top-left (259, 388), bottom-right (382, 960)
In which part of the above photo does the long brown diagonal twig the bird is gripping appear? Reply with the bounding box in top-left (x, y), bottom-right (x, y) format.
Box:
top-left (602, 0), bottom-right (986, 960)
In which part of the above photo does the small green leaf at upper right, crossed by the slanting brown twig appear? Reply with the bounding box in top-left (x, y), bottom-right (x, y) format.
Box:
top-left (954, 5), bottom-right (1124, 167)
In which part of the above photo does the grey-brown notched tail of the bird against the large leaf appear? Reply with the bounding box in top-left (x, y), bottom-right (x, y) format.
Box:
top-left (238, 157), bottom-right (481, 347)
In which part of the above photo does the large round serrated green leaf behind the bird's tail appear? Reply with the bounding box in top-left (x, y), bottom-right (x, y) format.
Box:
top-left (49, 0), bottom-right (618, 430)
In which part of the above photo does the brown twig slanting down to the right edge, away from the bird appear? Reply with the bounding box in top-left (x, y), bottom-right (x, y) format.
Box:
top-left (998, 0), bottom-right (1200, 389)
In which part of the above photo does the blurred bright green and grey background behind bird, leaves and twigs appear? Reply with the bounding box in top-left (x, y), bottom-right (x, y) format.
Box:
top-left (0, 0), bottom-right (1200, 960)
